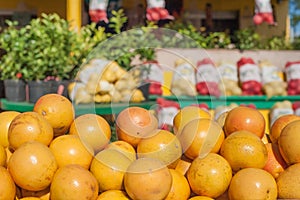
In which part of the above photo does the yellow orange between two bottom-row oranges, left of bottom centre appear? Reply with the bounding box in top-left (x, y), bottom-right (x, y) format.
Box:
top-left (90, 149), bottom-right (132, 192)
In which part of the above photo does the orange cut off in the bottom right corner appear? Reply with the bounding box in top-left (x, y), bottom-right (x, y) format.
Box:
top-left (276, 163), bottom-right (300, 199)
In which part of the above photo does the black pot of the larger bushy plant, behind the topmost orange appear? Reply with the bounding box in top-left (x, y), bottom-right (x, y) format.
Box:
top-left (28, 80), bottom-right (52, 103)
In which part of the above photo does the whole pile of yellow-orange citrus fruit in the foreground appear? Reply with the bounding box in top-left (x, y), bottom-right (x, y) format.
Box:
top-left (0, 94), bottom-right (300, 200)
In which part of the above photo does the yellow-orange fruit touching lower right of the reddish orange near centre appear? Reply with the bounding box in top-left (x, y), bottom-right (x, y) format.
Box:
top-left (136, 129), bottom-right (182, 168)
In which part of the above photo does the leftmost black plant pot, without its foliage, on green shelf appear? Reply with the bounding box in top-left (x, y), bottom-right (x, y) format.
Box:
top-left (4, 79), bottom-right (26, 102)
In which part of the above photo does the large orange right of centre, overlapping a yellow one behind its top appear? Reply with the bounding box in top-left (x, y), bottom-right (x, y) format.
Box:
top-left (178, 118), bottom-right (225, 159)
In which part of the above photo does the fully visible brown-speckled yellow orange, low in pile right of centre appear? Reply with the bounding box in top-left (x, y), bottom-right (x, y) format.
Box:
top-left (187, 153), bottom-right (232, 198)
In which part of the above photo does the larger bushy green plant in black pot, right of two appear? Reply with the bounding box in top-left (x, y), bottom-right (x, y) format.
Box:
top-left (23, 14), bottom-right (77, 102)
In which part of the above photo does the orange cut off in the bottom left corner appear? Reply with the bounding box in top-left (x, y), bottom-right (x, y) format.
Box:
top-left (0, 166), bottom-right (16, 200)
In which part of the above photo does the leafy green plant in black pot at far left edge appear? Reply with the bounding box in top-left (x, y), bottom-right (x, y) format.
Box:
top-left (0, 21), bottom-right (28, 101)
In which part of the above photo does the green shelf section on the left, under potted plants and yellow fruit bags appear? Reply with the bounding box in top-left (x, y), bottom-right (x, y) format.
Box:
top-left (1, 99), bottom-right (155, 115)
